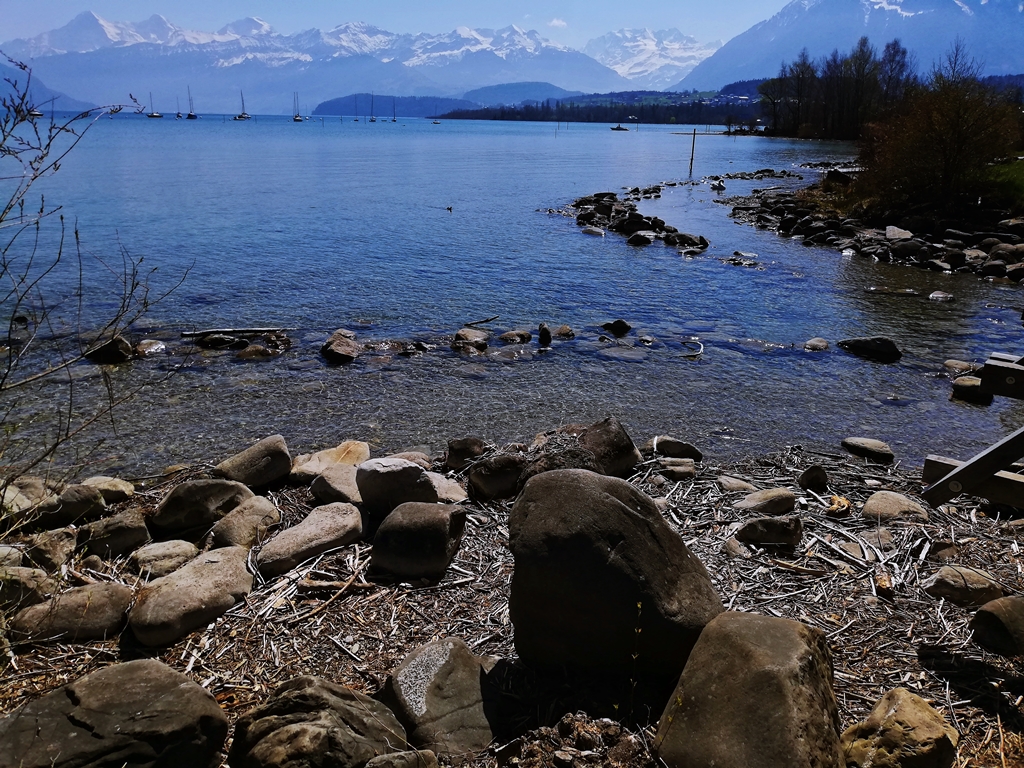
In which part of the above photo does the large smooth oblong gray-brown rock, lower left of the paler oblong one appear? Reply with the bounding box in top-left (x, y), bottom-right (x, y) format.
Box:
top-left (128, 547), bottom-right (253, 646)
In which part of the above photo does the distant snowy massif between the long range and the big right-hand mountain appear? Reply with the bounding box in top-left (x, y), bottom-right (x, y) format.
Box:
top-left (583, 29), bottom-right (722, 90)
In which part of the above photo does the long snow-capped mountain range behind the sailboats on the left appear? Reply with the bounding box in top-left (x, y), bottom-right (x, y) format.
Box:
top-left (0, 12), bottom-right (636, 113)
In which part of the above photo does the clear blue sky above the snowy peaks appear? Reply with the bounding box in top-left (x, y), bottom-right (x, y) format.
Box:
top-left (0, 0), bottom-right (786, 47)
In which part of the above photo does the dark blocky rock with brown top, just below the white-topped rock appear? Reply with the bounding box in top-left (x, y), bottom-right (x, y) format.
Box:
top-left (370, 502), bottom-right (466, 579)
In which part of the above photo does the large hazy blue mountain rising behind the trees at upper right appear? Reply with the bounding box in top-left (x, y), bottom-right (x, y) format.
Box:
top-left (678, 0), bottom-right (1024, 90)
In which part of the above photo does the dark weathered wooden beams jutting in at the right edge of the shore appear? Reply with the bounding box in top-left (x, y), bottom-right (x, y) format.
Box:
top-left (922, 354), bottom-right (1024, 508)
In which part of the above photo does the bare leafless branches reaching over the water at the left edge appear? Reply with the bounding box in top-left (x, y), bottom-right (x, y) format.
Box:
top-left (0, 58), bottom-right (183, 527)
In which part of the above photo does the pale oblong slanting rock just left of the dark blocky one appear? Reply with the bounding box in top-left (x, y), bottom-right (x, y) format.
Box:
top-left (256, 502), bottom-right (362, 579)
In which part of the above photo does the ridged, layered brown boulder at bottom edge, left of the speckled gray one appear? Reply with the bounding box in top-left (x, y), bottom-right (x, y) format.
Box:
top-left (227, 676), bottom-right (408, 768)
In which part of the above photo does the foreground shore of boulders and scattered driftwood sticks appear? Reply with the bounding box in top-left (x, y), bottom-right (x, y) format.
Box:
top-left (0, 417), bottom-right (1024, 768)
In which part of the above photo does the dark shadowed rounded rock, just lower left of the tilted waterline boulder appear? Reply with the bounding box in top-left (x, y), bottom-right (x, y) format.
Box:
top-left (146, 479), bottom-right (254, 541)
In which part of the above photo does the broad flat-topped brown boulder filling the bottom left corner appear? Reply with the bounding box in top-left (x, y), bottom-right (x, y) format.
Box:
top-left (0, 658), bottom-right (227, 768)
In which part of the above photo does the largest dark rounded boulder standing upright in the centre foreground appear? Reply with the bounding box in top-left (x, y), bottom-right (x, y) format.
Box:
top-left (509, 469), bottom-right (722, 677)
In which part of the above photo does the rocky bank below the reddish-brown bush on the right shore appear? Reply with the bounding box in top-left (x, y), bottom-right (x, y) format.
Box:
top-left (725, 186), bottom-right (1024, 286)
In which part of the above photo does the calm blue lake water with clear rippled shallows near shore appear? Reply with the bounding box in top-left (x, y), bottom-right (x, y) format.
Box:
top-left (9, 115), bottom-right (1024, 473)
